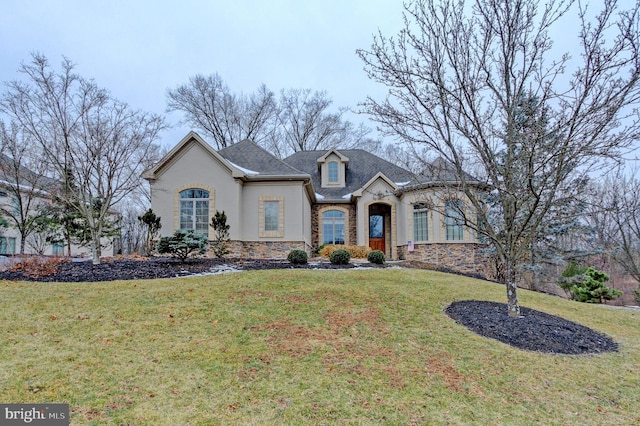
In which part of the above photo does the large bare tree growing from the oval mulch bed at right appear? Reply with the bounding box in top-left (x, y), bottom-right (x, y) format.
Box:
top-left (358, 0), bottom-right (640, 316)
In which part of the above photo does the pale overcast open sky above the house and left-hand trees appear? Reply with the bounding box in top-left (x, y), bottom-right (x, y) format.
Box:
top-left (0, 0), bottom-right (403, 147)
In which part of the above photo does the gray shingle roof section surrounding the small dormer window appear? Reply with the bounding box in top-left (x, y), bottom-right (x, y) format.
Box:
top-left (283, 149), bottom-right (416, 200)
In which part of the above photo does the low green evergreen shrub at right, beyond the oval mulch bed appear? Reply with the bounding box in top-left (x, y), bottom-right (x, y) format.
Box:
top-left (558, 263), bottom-right (622, 303)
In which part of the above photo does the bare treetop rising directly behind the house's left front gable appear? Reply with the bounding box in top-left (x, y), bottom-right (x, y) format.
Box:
top-left (167, 74), bottom-right (276, 149)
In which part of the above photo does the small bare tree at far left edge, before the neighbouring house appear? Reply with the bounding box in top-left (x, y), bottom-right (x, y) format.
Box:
top-left (0, 121), bottom-right (58, 254)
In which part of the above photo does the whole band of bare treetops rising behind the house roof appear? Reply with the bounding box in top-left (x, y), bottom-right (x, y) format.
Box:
top-left (167, 74), bottom-right (375, 158)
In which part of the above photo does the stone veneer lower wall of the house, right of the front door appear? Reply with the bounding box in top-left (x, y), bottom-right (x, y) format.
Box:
top-left (398, 243), bottom-right (495, 279)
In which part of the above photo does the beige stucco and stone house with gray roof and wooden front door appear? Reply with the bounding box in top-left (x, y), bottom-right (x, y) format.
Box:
top-left (143, 132), bottom-right (487, 275)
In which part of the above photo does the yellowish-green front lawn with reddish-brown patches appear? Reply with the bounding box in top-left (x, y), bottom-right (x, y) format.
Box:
top-left (0, 269), bottom-right (640, 425)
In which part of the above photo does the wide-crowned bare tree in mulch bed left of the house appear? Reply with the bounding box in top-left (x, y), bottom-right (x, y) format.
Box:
top-left (0, 54), bottom-right (166, 263)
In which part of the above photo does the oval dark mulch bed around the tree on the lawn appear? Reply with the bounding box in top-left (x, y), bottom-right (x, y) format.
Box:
top-left (445, 300), bottom-right (618, 355)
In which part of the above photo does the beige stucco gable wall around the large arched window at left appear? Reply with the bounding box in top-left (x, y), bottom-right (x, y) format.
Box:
top-left (151, 143), bottom-right (242, 239)
